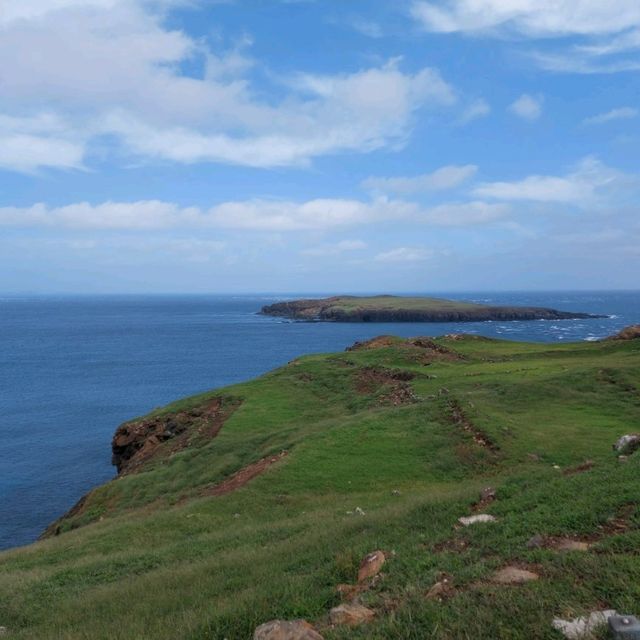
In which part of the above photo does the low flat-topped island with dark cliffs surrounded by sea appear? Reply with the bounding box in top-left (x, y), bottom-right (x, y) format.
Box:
top-left (260, 295), bottom-right (602, 322)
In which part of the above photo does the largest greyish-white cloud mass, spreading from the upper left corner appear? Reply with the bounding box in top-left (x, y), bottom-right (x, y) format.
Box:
top-left (0, 0), bottom-right (456, 170)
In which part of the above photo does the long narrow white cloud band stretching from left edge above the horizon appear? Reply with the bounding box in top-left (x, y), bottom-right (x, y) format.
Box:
top-left (0, 198), bottom-right (509, 235)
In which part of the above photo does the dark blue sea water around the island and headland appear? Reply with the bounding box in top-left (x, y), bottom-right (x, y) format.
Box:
top-left (0, 292), bottom-right (640, 549)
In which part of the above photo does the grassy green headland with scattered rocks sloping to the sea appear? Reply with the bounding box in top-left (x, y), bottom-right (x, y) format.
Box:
top-left (0, 327), bottom-right (640, 640)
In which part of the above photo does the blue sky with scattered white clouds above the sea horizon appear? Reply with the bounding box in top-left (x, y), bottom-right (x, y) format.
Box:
top-left (0, 0), bottom-right (640, 293)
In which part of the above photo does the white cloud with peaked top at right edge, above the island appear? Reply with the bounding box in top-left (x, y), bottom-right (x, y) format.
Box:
top-left (474, 157), bottom-right (637, 205)
